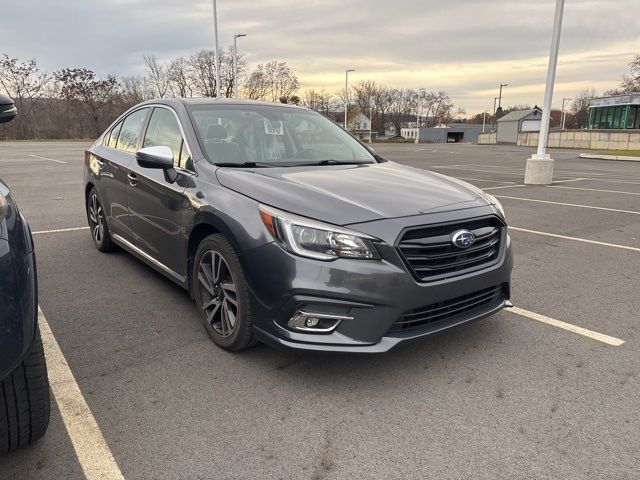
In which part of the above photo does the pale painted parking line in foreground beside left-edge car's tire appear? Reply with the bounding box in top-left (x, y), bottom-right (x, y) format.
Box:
top-left (38, 311), bottom-right (124, 480)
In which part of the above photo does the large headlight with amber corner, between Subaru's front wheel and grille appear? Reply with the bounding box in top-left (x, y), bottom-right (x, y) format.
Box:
top-left (258, 205), bottom-right (380, 260)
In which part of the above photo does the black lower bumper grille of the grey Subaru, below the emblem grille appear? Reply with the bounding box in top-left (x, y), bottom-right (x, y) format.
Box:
top-left (389, 284), bottom-right (509, 332)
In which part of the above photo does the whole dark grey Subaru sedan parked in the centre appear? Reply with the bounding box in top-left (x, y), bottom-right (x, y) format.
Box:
top-left (85, 99), bottom-right (513, 352)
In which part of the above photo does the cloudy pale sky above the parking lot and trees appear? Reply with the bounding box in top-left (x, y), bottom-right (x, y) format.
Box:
top-left (0, 0), bottom-right (640, 114)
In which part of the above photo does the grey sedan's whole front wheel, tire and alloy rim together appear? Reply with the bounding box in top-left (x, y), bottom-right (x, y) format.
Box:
top-left (192, 234), bottom-right (254, 351)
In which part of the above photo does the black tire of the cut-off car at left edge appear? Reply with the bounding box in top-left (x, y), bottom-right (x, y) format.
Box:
top-left (0, 330), bottom-right (50, 455)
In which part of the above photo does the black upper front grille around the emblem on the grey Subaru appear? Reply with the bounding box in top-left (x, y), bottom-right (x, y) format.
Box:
top-left (398, 217), bottom-right (504, 281)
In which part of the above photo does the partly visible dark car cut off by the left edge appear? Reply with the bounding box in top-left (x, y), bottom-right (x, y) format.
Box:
top-left (0, 95), bottom-right (49, 454)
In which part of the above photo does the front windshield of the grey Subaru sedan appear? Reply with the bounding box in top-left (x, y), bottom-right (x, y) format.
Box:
top-left (190, 105), bottom-right (376, 167)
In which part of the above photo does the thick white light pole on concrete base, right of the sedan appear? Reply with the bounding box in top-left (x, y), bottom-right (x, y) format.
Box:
top-left (524, 0), bottom-right (564, 185)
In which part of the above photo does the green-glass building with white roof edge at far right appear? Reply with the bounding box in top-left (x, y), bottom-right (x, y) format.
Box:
top-left (589, 94), bottom-right (640, 130)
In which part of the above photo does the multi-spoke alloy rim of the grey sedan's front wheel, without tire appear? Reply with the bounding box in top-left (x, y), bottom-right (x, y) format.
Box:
top-left (198, 250), bottom-right (238, 338)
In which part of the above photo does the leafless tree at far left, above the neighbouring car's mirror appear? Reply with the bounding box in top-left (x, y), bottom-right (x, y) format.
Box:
top-left (0, 54), bottom-right (51, 138)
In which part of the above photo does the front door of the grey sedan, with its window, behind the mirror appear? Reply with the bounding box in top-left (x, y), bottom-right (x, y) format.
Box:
top-left (127, 106), bottom-right (191, 281)
